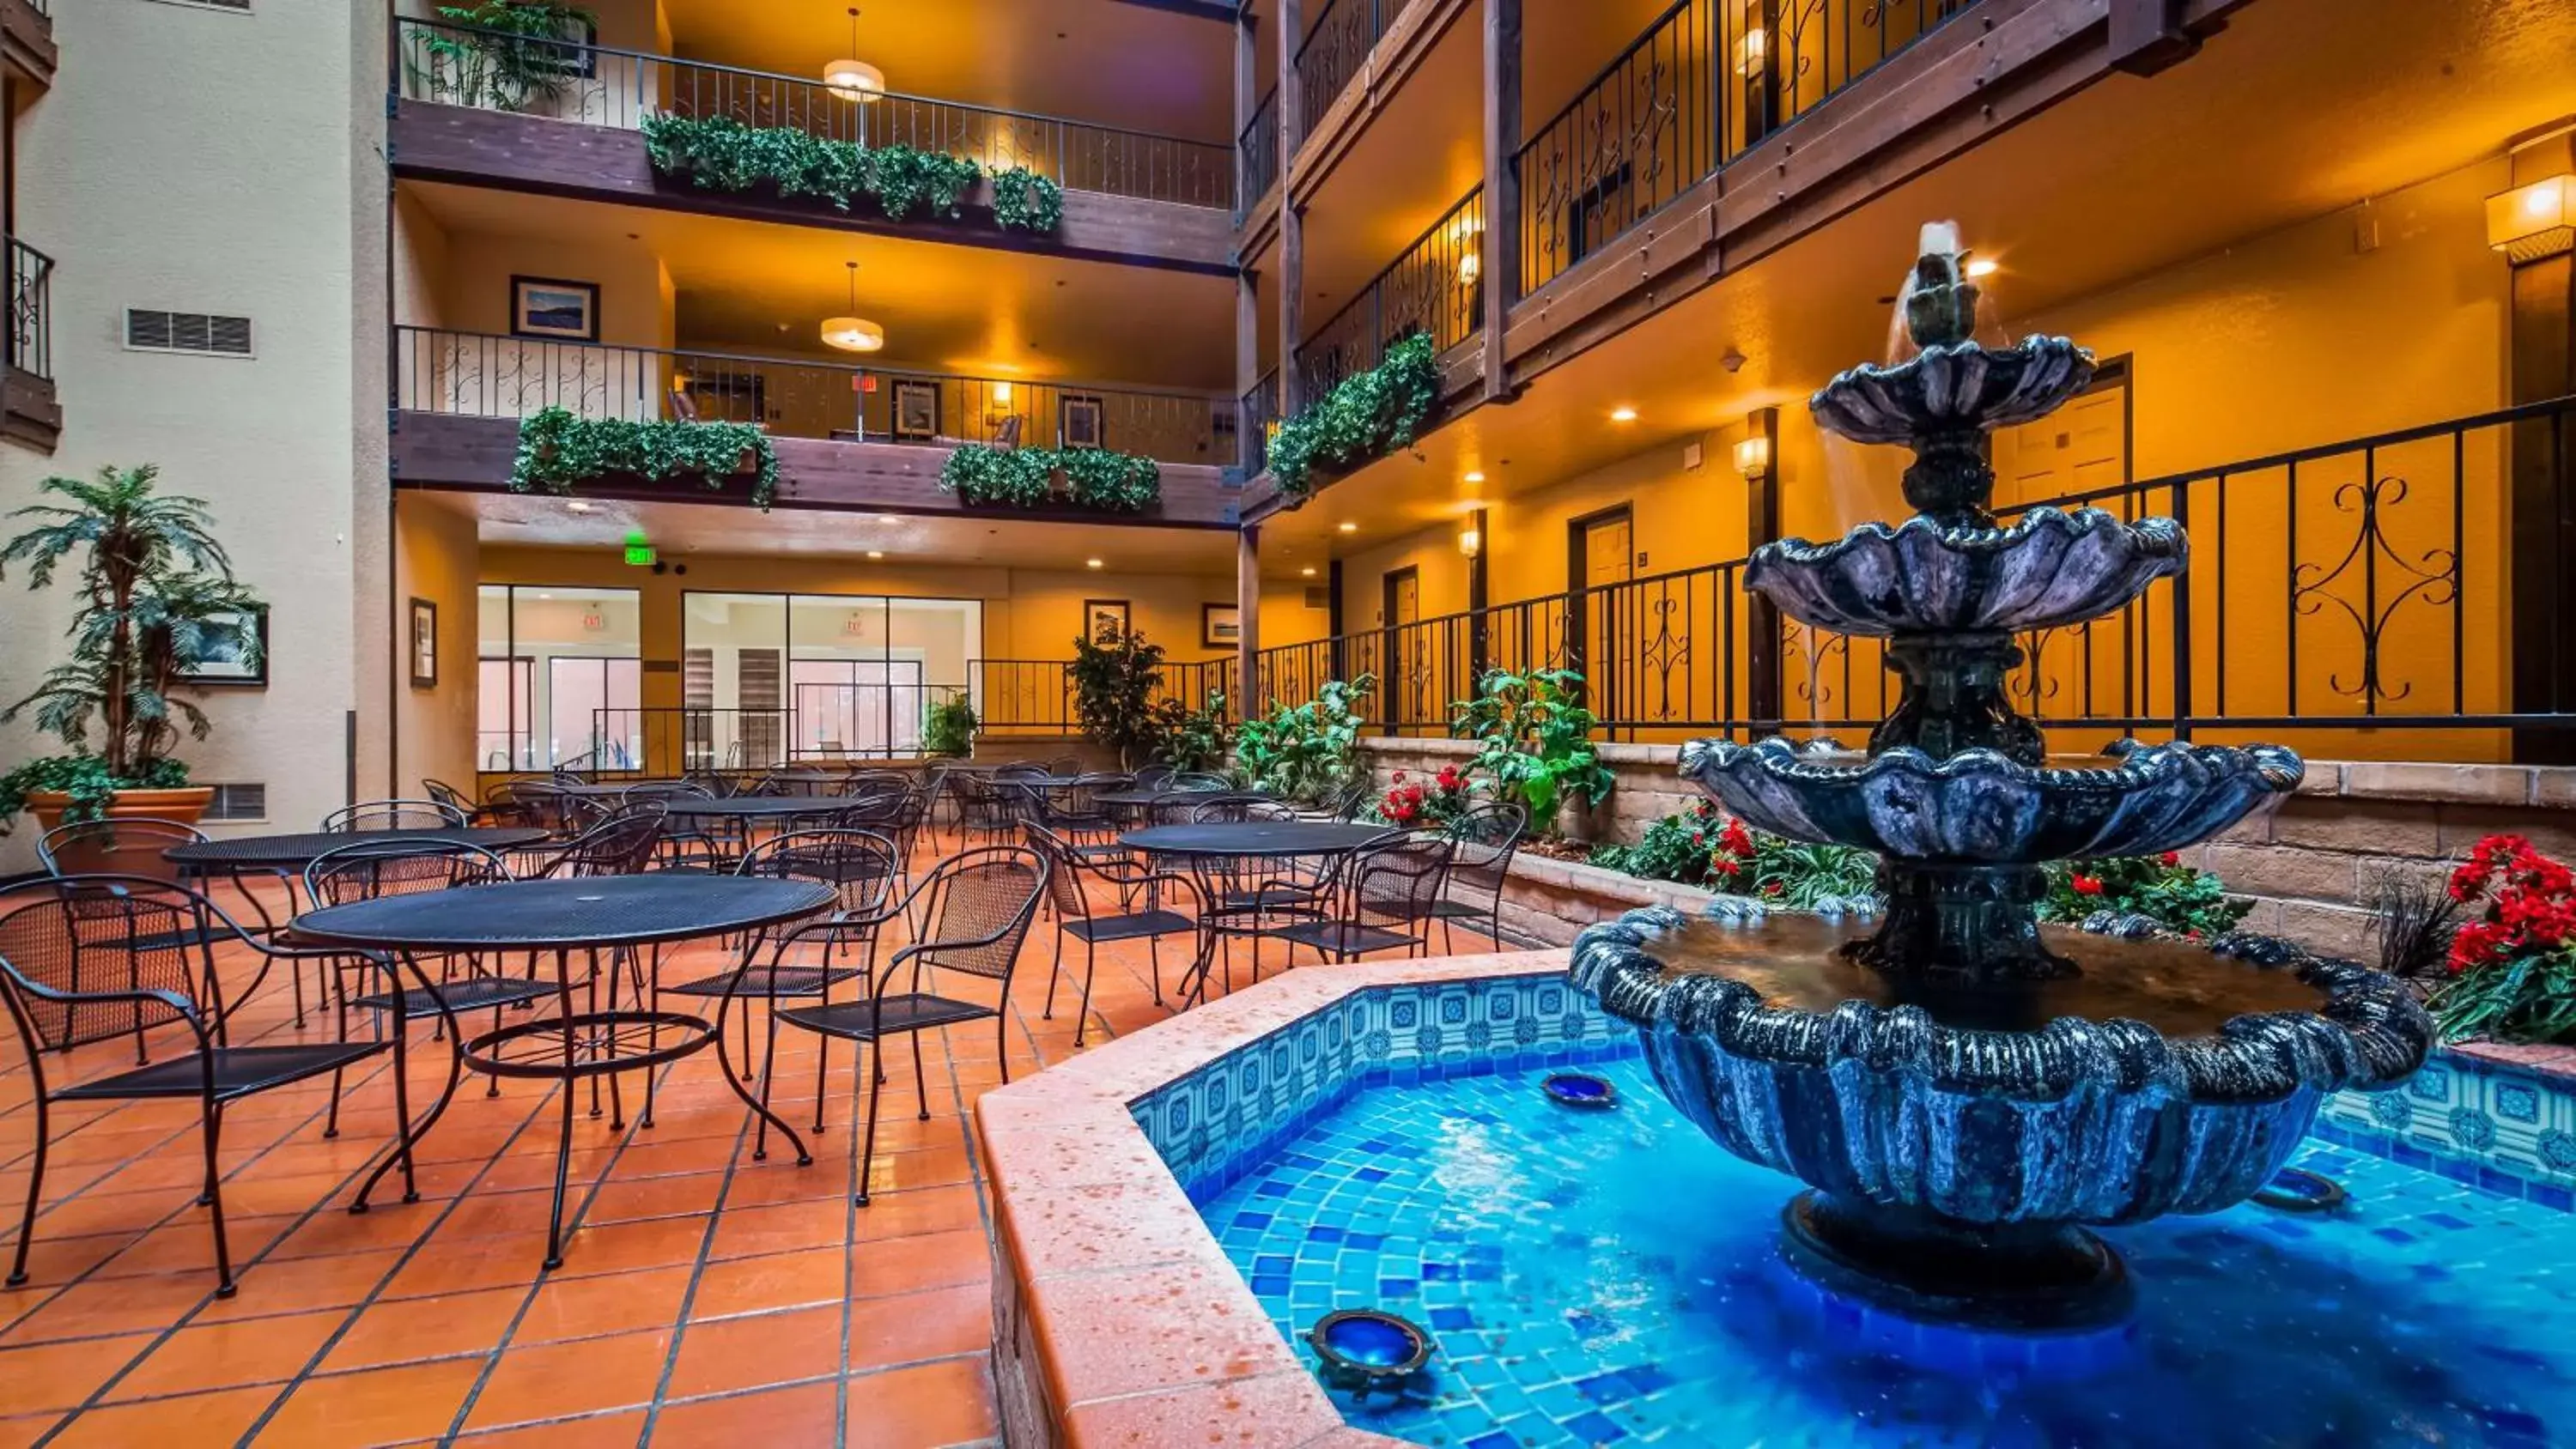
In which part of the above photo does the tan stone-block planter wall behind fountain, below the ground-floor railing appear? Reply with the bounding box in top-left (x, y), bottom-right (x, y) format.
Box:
top-left (1363, 738), bottom-right (2576, 960)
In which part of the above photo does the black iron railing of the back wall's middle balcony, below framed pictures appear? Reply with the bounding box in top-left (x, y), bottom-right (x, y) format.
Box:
top-left (394, 327), bottom-right (1236, 466)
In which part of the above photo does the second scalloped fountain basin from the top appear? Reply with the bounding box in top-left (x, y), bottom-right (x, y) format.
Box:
top-left (1744, 507), bottom-right (2190, 636)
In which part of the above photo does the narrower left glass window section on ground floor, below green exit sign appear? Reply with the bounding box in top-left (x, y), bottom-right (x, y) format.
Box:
top-left (474, 585), bottom-right (644, 769)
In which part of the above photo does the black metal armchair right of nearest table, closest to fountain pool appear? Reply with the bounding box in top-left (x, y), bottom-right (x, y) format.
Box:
top-left (760, 846), bottom-right (1048, 1207)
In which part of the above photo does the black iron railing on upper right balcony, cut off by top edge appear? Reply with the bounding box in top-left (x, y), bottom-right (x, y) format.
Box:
top-left (1512, 0), bottom-right (1973, 299)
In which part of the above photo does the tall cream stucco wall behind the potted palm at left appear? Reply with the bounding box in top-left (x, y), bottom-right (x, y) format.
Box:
top-left (0, 0), bottom-right (386, 864)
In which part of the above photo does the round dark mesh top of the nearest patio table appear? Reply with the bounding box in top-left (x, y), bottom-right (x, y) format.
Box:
top-left (291, 875), bottom-right (837, 952)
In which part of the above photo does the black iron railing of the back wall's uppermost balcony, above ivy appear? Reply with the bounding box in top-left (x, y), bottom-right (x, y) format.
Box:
top-left (394, 21), bottom-right (1236, 209)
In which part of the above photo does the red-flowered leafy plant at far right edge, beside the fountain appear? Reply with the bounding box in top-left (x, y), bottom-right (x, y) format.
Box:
top-left (2429, 834), bottom-right (2576, 1042)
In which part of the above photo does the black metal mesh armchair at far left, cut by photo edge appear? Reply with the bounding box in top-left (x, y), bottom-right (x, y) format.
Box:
top-left (0, 875), bottom-right (420, 1297)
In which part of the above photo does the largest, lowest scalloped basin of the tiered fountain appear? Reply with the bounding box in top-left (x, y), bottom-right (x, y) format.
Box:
top-left (1574, 906), bottom-right (2432, 1225)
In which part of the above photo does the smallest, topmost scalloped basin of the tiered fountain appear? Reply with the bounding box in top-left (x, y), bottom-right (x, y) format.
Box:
top-left (1808, 337), bottom-right (2094, 443)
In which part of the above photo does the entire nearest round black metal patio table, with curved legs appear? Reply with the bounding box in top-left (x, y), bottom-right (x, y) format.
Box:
top-left (289, 875), bottom-right (837, 1269)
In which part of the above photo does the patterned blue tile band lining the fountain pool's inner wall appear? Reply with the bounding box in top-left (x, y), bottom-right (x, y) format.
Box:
top-left (1128, 975), bottom-right (2576, 1212)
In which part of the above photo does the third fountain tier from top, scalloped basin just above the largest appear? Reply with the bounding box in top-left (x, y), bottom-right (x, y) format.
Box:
top-left (1682, 738), bottom-right (2303, 867)
